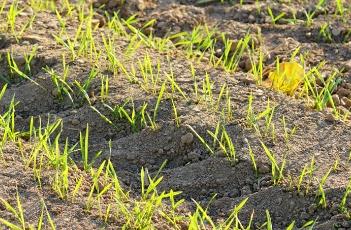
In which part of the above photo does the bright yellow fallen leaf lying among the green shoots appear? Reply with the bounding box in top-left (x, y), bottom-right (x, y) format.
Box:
top-left (268, 62), bottom-right (304, 95)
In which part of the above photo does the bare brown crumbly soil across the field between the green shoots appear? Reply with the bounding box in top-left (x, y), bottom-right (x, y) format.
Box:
top-left (0, 0), bottom-right (351, 229)
